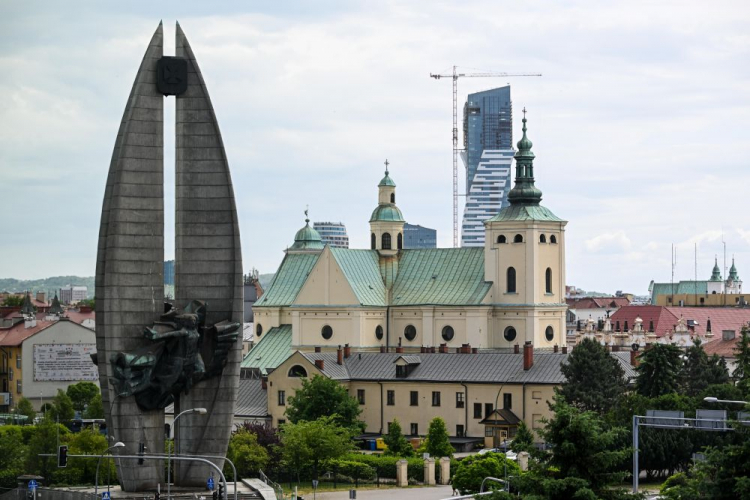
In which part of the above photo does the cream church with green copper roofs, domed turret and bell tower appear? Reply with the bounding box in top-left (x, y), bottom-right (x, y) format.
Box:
top-left (253, 117), bottom-right (567, 360)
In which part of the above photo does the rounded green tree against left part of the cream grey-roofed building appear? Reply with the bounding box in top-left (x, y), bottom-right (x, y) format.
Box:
top-left (286, 375), bottom-right (362, 430)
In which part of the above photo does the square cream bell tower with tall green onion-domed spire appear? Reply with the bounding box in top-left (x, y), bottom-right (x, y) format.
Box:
top-left (484, 113), bottom-right (567, 348)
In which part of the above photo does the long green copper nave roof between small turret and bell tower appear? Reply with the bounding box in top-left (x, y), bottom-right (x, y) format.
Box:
top-left (391, 248), bottom-right (492, 306)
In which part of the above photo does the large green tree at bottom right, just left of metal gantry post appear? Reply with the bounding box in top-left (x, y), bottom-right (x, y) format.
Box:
top-left (540, 399), bottom-right (630, 495)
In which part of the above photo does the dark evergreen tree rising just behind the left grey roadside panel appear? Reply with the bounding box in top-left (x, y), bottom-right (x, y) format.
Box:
top-left (635, 344), bottom-right (682, 398)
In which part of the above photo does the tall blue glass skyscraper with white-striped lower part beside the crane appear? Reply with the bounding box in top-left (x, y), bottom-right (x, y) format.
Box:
top-left (461, 86), bottom-right (514, 247)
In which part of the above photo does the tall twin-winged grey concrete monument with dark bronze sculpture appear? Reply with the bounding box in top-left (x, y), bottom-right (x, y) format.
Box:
top-left (96, 23), bottom-right (243, 491)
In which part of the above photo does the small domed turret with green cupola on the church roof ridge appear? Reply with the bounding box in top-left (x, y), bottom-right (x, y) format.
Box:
top-left (370, 160), bottom-right (404, 255)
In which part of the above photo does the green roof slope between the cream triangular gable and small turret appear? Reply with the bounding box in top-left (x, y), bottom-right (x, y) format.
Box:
top-left (331, 247), bottom-right (386, 306)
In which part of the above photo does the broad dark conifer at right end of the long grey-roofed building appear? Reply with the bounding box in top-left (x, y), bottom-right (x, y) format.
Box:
top-left (560, 339), bottom-right (626, 413)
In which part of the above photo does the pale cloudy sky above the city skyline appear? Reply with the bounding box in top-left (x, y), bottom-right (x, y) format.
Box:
top-left (0, 0), bottom-right (750, 293)
